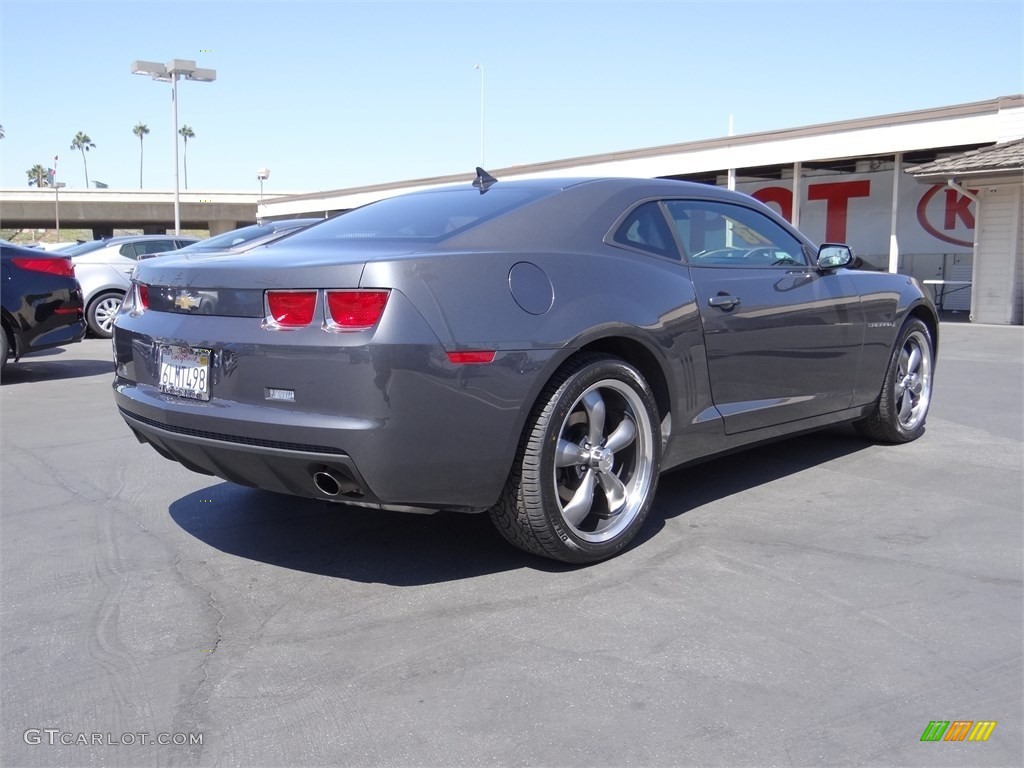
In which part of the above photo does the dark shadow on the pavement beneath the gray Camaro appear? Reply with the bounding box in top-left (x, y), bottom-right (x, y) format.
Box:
top-left (169, 428), bottom-right (870, 587)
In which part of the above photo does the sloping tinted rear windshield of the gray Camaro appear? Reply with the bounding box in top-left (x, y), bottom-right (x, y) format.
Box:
top-left (292, 185), bottom-right (553, 242)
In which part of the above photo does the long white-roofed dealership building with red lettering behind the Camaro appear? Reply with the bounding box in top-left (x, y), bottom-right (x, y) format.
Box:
top-left (260, 94), bottom-right (1024, 325)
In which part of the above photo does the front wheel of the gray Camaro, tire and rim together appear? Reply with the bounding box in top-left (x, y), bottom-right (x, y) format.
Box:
top-left (854, 317), bottom-right (935, 443)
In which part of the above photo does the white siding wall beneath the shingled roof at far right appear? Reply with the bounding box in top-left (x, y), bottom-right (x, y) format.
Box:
top-left (968, 181), bottom-right (1022, 325)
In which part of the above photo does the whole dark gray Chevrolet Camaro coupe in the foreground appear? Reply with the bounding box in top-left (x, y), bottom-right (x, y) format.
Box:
top-left (114, 171), bottom-right (938, 563)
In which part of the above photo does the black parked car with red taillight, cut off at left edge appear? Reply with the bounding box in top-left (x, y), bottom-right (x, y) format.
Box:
top-left (0, 241), bottom-right (85, 369)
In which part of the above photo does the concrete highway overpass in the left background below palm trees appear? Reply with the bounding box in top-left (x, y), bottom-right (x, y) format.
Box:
top-left (0, 186), bottom-right (294, 238)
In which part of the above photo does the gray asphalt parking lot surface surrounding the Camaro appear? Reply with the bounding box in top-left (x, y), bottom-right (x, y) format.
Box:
top-left (0, 324), bottom-right (1024, 766)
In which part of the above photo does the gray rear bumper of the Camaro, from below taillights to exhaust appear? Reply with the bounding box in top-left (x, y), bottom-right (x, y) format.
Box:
top-left (114, 302), bottom-right (554, 509)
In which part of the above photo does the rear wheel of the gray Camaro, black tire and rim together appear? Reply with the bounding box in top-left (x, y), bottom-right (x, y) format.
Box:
top-left (490, 353), bottom-right (662, 563)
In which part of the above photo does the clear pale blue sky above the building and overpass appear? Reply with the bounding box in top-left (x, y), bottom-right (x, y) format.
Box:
top-left (0, 0), bottom-right (1024, 196)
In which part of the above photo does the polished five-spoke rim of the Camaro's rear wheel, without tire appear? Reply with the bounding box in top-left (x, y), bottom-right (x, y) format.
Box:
top-left (553, 379), bottom-right (654, 543)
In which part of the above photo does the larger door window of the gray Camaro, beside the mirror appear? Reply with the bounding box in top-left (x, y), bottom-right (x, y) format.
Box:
top-left (666, 200), bottom-right (807, 267)
